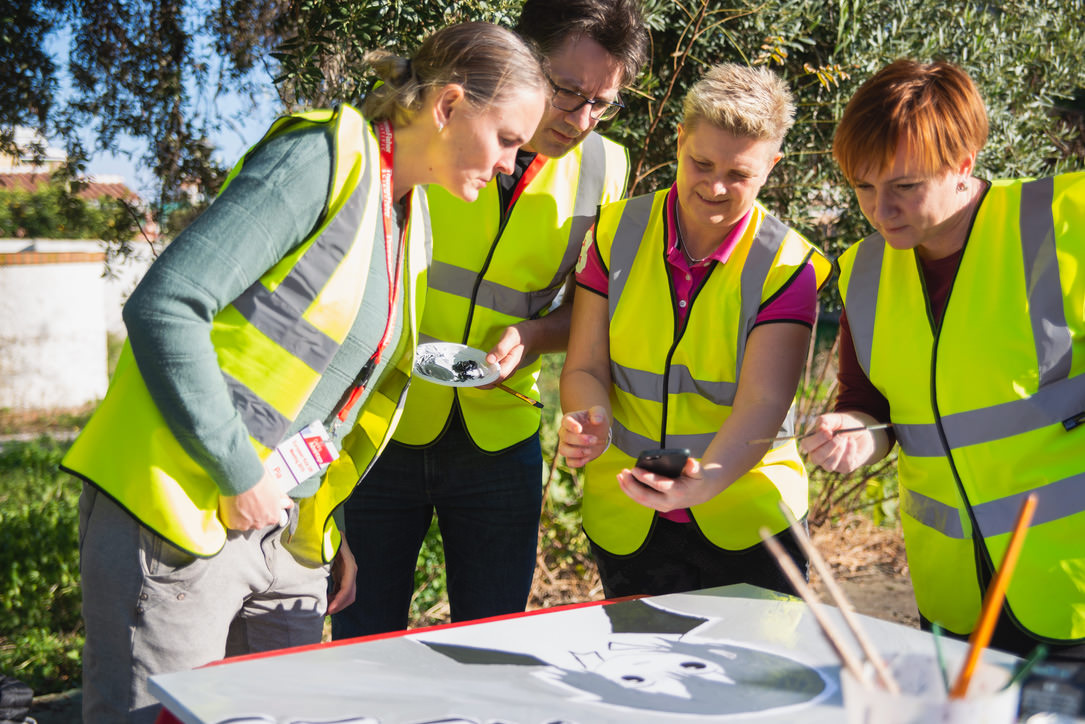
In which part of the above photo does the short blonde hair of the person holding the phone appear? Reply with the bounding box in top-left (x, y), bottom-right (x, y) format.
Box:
top-left (682, 63), bottom-right (795, 143)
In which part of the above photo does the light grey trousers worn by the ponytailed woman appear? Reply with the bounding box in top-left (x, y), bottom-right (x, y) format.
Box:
top-left (79, 484), bottom-right (328, 724)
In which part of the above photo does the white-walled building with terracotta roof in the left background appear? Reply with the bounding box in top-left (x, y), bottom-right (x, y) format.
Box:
top-left (0, 129), bottom-right (157, 410)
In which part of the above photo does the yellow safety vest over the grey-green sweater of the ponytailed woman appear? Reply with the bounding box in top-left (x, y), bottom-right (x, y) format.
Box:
top-left (62, 105), bottom-right (429, 564)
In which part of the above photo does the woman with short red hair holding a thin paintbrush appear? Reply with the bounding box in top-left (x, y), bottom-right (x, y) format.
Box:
top-left (803, 60), bottom-right (1085, 660)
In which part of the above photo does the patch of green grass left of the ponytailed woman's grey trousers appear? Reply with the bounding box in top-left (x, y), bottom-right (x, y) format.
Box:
top-left (0, 437), bottom-right (82, 694)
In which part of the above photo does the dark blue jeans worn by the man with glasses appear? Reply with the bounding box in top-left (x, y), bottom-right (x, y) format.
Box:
top-left (332, 410), bottom-right (543, 639)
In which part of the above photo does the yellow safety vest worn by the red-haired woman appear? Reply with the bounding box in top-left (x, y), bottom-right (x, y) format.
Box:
top-left (840, 173), bottom-right (1085, 644)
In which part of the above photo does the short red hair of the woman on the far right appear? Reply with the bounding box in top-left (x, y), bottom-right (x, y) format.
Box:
top-left (832, 59), bottom-right (987, 181)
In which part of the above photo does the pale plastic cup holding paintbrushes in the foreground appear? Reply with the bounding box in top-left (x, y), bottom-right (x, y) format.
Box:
top-left (840, 653), bottom-right (1021, 724)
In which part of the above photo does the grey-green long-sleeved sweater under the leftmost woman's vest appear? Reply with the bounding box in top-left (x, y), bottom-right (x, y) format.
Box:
top-left (124, 123), bottom-right (406, 498)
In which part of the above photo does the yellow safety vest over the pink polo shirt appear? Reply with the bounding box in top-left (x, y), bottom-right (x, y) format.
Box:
top-left (584, 189), bottom-right (831, 555)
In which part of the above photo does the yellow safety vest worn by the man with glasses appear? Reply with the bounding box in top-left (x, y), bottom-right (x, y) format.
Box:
top-left (395, 134), bottom-right (628, 452)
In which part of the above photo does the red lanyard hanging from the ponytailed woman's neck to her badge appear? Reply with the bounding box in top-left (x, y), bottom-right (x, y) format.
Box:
top-left (332, 120), bottom-right (411, 430)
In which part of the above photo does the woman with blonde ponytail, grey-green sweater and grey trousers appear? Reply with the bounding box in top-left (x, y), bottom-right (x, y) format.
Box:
top-left (63, 23), bottom-right (549, 722)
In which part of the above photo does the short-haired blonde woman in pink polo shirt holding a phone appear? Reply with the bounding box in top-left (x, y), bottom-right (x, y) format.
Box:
top-left (559, 64), bottom-right (829, 597)
